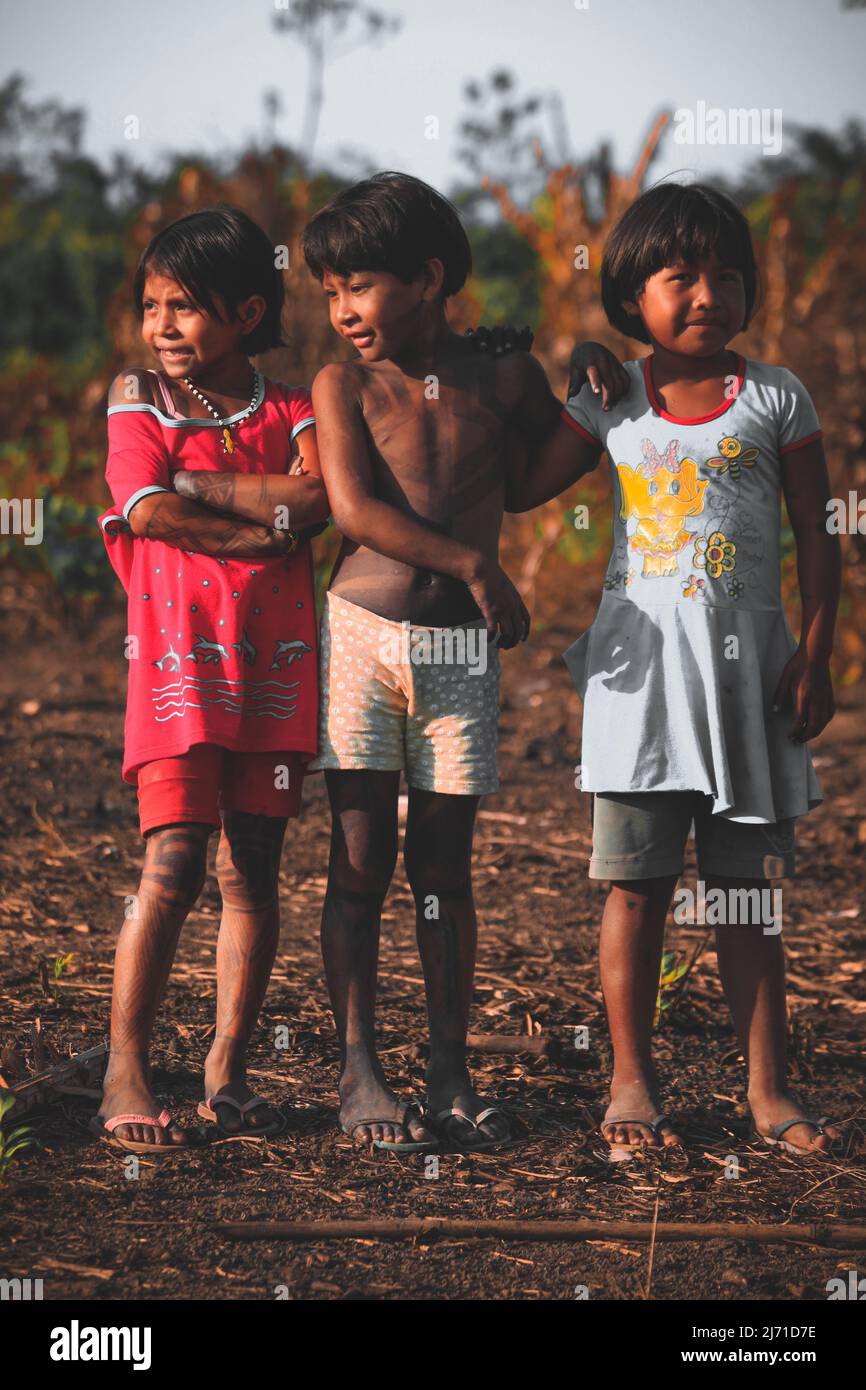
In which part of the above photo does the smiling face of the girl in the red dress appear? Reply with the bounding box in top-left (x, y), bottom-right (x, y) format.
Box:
top-left (142, 271), bottom-right (265, 379)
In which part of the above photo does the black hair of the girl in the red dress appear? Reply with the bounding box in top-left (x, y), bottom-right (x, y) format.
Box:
top-left (132, 203), bottom-right (285, 357)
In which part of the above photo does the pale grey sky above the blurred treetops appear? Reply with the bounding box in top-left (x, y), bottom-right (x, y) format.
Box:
top-left (0, 0), bottom-right (866, 192)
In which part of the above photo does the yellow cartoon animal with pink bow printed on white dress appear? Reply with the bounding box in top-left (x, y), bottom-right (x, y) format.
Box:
top-left (617, 439), bottom-right (709, 578)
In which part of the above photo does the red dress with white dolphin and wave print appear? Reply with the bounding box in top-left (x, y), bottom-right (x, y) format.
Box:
top-left (99, 373), bottom-right (318, 783)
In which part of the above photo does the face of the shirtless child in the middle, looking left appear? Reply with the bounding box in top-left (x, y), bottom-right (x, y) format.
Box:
top-left (322, 260), bottom-right (443, 361)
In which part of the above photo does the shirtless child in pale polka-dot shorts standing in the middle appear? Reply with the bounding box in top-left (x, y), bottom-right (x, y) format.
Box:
top-left (303, 174), bottom-right (613, 1150)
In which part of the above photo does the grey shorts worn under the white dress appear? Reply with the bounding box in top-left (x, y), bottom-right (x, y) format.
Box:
top-left (589, 791), bottom-right (796, 878)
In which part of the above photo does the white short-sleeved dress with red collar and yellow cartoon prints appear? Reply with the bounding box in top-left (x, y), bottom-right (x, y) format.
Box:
top-left (563, 357), bottom-right (822, 823)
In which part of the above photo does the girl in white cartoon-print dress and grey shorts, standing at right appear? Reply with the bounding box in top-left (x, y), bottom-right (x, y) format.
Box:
top-left (507, 183), bottom-right (841, 1158)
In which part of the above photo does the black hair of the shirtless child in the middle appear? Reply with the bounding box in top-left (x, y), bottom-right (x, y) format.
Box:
top-left (302, 171), bottom-right (473, 299)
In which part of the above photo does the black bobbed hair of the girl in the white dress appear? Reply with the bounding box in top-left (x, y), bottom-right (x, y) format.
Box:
top-left (602, 183), bottom-right (758, 343)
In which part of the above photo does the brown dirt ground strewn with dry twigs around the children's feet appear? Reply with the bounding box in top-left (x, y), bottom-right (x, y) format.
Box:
top-left (0, 578), bottom-right (866, 1301)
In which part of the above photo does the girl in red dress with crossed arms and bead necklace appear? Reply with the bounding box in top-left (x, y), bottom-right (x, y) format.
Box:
top-left (93, 207), bottom-right (329, 1152)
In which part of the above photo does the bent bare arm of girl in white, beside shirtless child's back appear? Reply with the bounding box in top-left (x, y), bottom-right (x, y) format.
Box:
top-left (496, 353), bottom-right (602, 512)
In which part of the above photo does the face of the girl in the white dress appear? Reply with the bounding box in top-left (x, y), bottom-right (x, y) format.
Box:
top-left (624, 254), bottom-right (745, 357)
